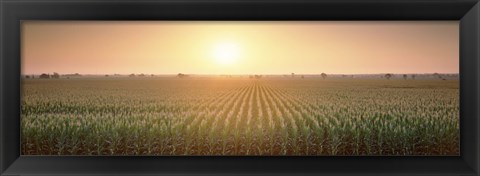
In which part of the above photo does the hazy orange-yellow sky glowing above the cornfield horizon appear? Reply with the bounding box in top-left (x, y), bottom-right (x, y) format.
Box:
top-left (22, 21), bottom-right (459, 74)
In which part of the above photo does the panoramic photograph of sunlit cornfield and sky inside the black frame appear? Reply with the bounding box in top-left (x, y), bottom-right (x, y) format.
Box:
top-left (20, 20), bottom-right (461, 156)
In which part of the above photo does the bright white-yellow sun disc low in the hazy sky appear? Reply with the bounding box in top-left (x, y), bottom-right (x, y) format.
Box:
top-left (212, 42), bottom-right (240, 65)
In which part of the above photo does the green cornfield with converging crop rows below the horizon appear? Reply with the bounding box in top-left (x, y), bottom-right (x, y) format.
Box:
top-left (21, 77), bottom-right (459, 155)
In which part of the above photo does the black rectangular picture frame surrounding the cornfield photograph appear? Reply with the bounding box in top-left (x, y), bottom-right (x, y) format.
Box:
top-left (0, 0), bottom-right (480, 176)
